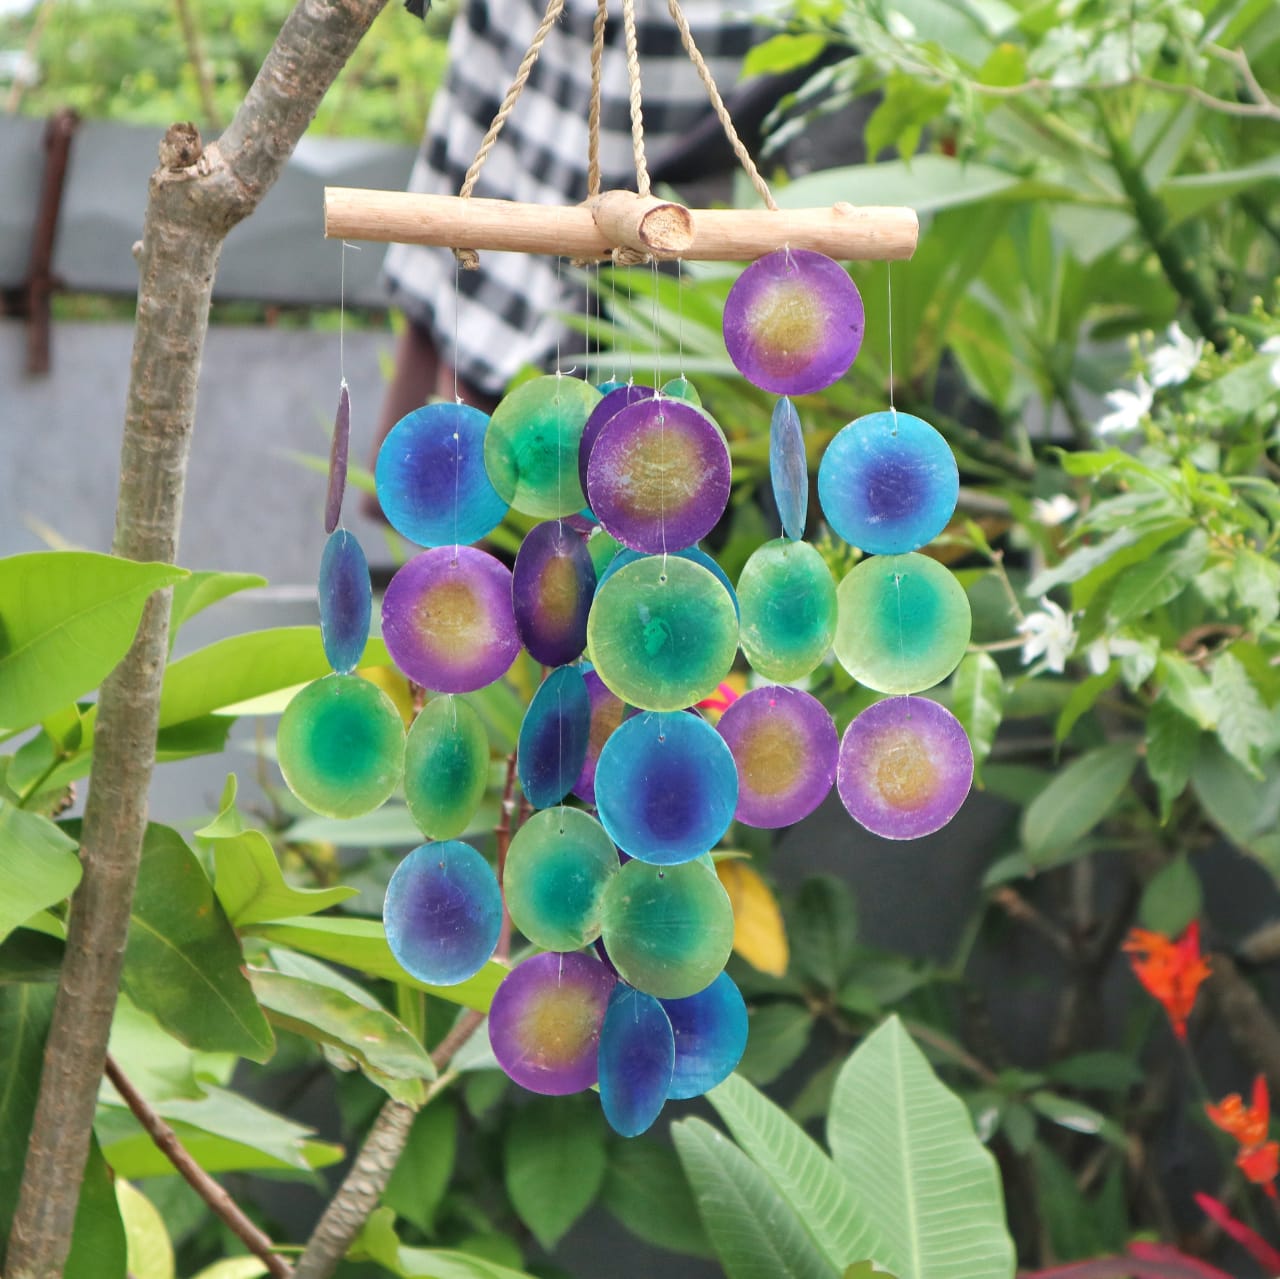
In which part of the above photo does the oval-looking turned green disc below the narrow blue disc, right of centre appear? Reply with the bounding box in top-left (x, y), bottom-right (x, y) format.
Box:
top-left (737, 538), bottom-right (838, 682)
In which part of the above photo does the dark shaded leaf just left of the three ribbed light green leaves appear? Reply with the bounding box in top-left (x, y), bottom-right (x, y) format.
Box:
top-left (600, 1138), bottom-right (714, 1257)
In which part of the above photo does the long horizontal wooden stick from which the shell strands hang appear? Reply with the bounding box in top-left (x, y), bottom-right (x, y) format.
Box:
top-left (324, 187), bottom-right (919, 261)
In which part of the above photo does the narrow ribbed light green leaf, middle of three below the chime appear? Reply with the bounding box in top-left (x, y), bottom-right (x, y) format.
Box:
top-left (707, 1075), bottom-right (883, 1269)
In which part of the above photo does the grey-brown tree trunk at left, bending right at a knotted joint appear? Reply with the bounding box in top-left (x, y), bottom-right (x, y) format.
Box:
top-left (5, 0), bottom-right (385, 1279)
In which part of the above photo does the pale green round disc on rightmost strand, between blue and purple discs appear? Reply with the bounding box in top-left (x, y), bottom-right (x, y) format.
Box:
top-left (836, 552), bottom-right (970, 693)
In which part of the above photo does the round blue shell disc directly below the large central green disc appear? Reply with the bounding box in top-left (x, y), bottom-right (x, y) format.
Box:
top-left (595, 713), bottom-right (737, 865)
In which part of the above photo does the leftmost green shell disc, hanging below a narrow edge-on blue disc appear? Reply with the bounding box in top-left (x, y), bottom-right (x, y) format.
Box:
top-left (276, 675), bottom-right (404, 817)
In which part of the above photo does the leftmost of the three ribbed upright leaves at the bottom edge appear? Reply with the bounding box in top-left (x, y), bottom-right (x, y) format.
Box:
top-left (671, 1119), bottom-right (840, 1279)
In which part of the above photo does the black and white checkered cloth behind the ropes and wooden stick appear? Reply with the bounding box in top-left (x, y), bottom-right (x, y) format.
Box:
top-left (385, 0), bottom-right (767, 396)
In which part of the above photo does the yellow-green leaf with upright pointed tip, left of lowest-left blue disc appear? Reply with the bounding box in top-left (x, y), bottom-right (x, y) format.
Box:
top-left (196, 773), bottom-right (358, 928)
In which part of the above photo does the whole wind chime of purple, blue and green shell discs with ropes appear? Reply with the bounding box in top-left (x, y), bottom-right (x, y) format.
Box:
top-left (279, 0), bottom-right (973, 1136)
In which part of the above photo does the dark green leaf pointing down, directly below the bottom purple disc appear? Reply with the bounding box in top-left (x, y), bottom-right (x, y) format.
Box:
top-left (503, 1097), bottom-right (605, 1252)
